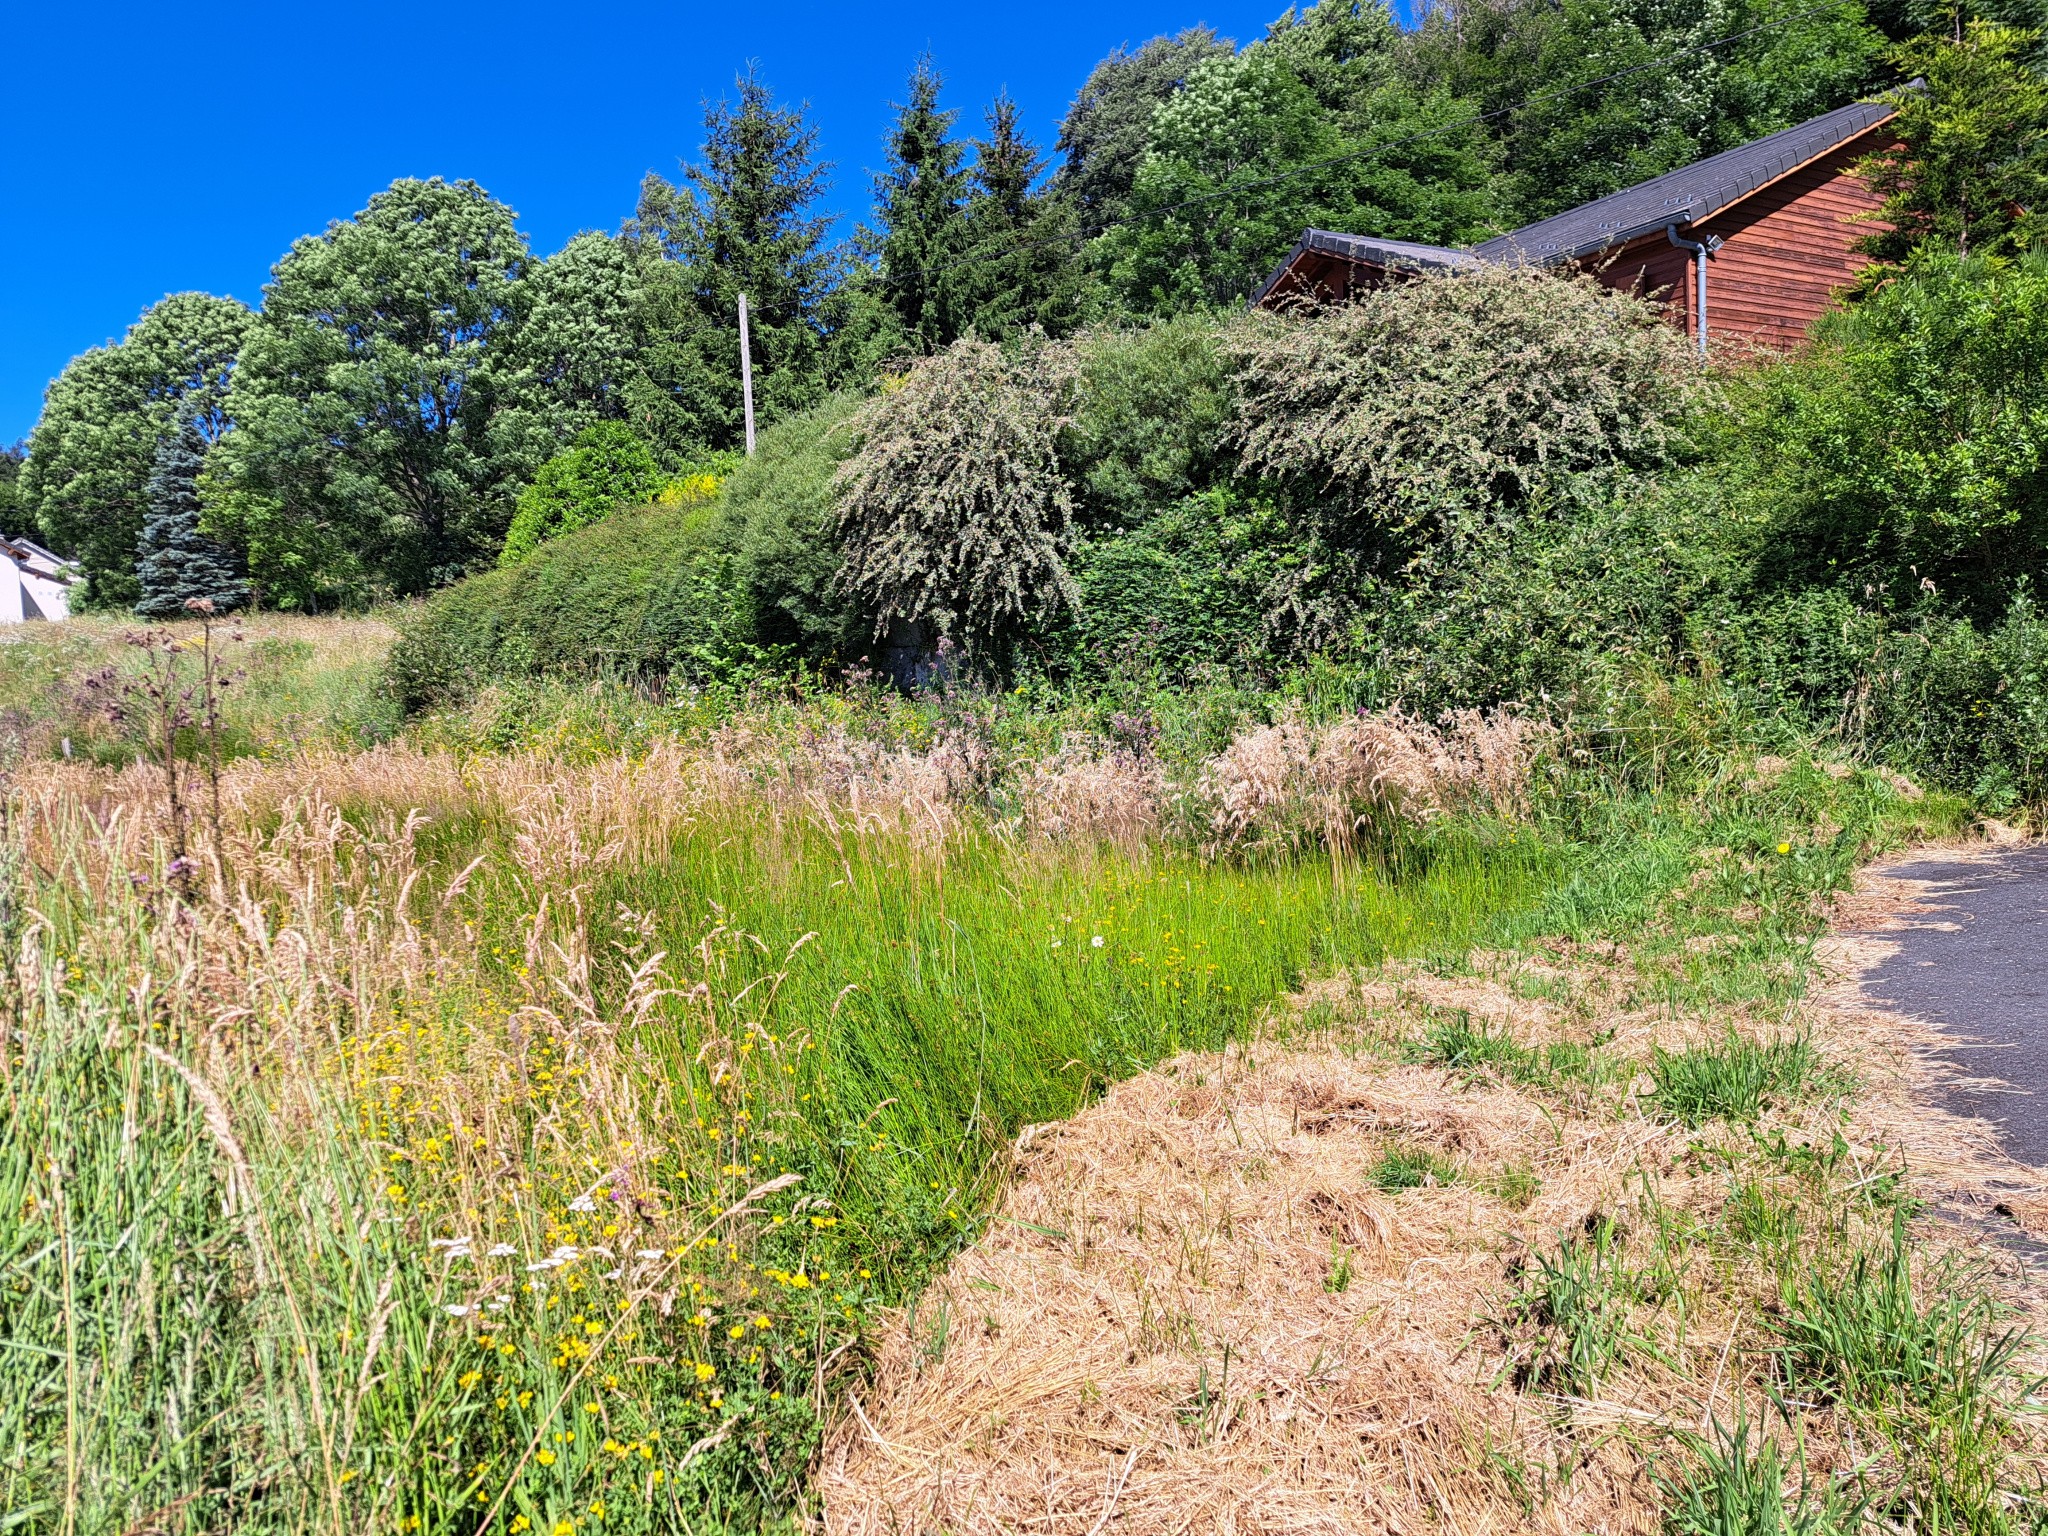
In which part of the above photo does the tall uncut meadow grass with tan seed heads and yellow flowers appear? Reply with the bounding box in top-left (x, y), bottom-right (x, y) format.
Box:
top-left (0, 657), bottom-right (2031, 1536)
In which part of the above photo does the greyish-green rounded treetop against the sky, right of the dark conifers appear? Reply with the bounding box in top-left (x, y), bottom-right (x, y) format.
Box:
top-left (1053, 27), bottom-right (1235, 233)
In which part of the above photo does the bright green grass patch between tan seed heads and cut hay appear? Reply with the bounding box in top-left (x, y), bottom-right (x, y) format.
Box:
top-left (561, 821), bottom-right (1563, 1286)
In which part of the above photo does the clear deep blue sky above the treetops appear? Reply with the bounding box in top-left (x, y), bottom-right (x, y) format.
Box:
top-left (0, 0), bottom-right (1310, 444)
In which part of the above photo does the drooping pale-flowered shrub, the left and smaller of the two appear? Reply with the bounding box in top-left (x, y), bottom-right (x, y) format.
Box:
top-left (838, 338), bottom-right (1075, 662)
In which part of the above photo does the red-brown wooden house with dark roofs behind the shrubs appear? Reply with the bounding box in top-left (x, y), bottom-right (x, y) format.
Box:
top-left (1257, 102), bottom-right (1892, 350)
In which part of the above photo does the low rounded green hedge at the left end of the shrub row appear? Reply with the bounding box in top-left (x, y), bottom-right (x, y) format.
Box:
top-left (389, 504), bottom-right (756, 711)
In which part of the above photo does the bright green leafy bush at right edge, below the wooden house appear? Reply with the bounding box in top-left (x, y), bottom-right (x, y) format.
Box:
top-left (1718, 254), bottom-right (2048, 618)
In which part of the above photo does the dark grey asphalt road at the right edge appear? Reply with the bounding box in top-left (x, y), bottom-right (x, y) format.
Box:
top-left (1864, 846), bottom-right (2048, 1167)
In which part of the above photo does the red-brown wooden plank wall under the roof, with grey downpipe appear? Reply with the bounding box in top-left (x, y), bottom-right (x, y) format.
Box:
top-left (1602, 135), bottom-right (1878, 350)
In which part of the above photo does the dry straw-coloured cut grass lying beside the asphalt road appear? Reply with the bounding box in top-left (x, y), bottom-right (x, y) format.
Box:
top-left (819, 847), bottom-right (2048, 1536)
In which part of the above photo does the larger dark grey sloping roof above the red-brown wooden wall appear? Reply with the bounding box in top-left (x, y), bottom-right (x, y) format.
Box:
top-left (1473, 100), bottom-right (1896, 262)
